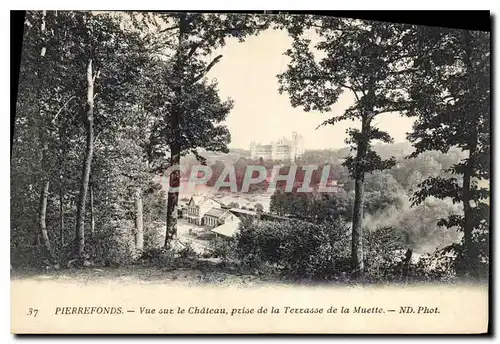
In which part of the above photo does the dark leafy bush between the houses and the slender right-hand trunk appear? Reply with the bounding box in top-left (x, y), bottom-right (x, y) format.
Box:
top-left (236, 219), bottom-right (350, 280)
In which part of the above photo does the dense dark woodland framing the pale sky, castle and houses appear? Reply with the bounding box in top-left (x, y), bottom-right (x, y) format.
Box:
top-left (11, 11), bottom-right (491, 282)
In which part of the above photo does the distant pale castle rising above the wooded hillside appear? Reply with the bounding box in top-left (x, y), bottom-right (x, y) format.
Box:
top-left (250, 132), bottom-right (304, 161)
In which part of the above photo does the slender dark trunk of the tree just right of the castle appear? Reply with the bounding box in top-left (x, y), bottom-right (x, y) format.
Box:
top-left (351, 116), bottom-right (370, 278)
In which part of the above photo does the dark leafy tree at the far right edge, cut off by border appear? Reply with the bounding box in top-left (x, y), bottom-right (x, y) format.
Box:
top-left (409, 27), bottom-right (490, 275)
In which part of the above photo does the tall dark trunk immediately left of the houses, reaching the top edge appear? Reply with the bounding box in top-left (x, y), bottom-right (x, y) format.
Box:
top-left (165, 13), bottom-right (186, 248)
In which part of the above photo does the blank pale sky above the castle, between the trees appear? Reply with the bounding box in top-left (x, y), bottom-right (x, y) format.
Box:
top-left (208, 30), bottom-right (413, 149)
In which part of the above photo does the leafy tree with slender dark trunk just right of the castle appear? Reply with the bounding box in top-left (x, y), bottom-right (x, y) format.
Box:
top-left (278, 15), bottom-right (407, 276)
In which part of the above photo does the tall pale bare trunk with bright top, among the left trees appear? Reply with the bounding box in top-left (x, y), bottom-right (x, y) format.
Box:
top-left (75, 59), bottom-right (94, 259)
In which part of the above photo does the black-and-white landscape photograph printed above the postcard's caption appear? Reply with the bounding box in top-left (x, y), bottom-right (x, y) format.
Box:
top-left (10, 10), bottom-right (491, 332)
